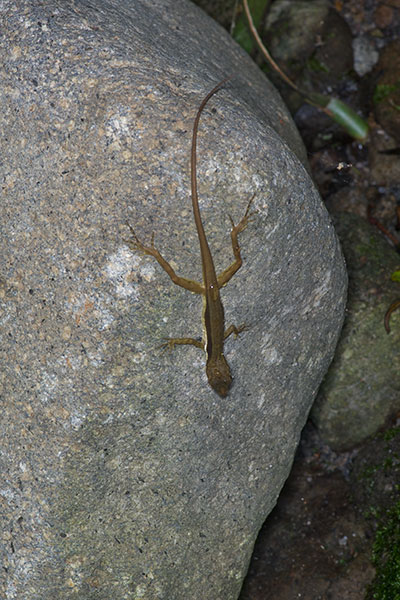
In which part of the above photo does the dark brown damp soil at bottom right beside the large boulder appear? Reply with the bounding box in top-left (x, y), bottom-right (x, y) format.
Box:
top-left (240, 422), bottom-right (390, 600)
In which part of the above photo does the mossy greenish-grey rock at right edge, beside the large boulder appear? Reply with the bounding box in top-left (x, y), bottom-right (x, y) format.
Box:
top-left (312, 213), bottom-right (400, 450)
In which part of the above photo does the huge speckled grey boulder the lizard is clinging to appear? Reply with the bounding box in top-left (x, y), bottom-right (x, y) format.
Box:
top-left (0, 0), bottom-right (346, 600)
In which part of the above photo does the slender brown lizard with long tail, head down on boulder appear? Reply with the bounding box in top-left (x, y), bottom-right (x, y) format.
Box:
top-left (127, 79), bottom-right (254, 398)
